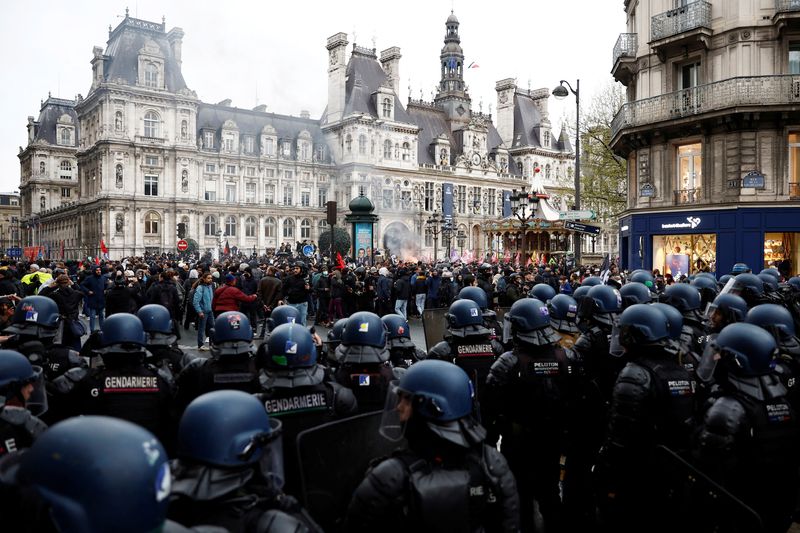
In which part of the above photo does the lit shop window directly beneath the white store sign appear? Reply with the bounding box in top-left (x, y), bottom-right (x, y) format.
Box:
top-left (653, 233), bottom-right (717, 279)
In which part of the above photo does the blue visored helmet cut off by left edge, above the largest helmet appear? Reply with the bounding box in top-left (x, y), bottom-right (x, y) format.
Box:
top-left (0, 350), bottom-right (47, 415)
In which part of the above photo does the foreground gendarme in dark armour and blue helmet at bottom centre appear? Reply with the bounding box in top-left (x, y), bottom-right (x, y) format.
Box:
top-left (345, 361), bottom-right (519, 532)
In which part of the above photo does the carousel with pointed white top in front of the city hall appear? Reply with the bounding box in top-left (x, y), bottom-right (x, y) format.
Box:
top-left (483, 175), bottom-right (577, 265)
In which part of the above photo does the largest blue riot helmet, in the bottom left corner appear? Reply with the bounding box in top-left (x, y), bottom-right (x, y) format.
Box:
top-left (0, 416), bottom-right (172, 533)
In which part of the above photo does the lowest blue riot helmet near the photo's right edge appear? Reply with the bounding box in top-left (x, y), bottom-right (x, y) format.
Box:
top-left (712, 322), bottom-right (777, 376)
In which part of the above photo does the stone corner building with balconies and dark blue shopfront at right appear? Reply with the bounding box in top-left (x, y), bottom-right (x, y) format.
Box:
top-left (611, 0), bottom-right (800, 275)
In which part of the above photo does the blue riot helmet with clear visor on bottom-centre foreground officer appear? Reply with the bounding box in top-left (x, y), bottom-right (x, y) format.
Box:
top-left (380, 359), bottom-right (486, 448)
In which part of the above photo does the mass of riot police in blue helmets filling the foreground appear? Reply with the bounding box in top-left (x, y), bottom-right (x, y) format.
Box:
top-left (0, 264), bottom-right (800, 532)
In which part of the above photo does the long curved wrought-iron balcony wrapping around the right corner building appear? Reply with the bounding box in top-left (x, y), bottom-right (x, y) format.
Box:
top-left (611, 75), bottom-right (800, 138)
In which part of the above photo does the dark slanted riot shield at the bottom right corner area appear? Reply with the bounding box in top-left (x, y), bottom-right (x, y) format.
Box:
top-left (655, 446), bottom-right (762, 533)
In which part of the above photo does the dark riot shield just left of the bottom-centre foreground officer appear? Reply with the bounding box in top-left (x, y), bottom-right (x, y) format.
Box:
top-left (297, 411), bottom-right (405, 532)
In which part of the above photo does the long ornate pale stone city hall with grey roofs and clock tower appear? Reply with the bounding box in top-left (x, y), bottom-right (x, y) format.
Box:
top-left (20, 14), bottom-right (574, 257)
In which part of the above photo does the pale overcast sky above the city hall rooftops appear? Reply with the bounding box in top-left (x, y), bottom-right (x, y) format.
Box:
top-left (0, 0), bottom-right (625, 191)
